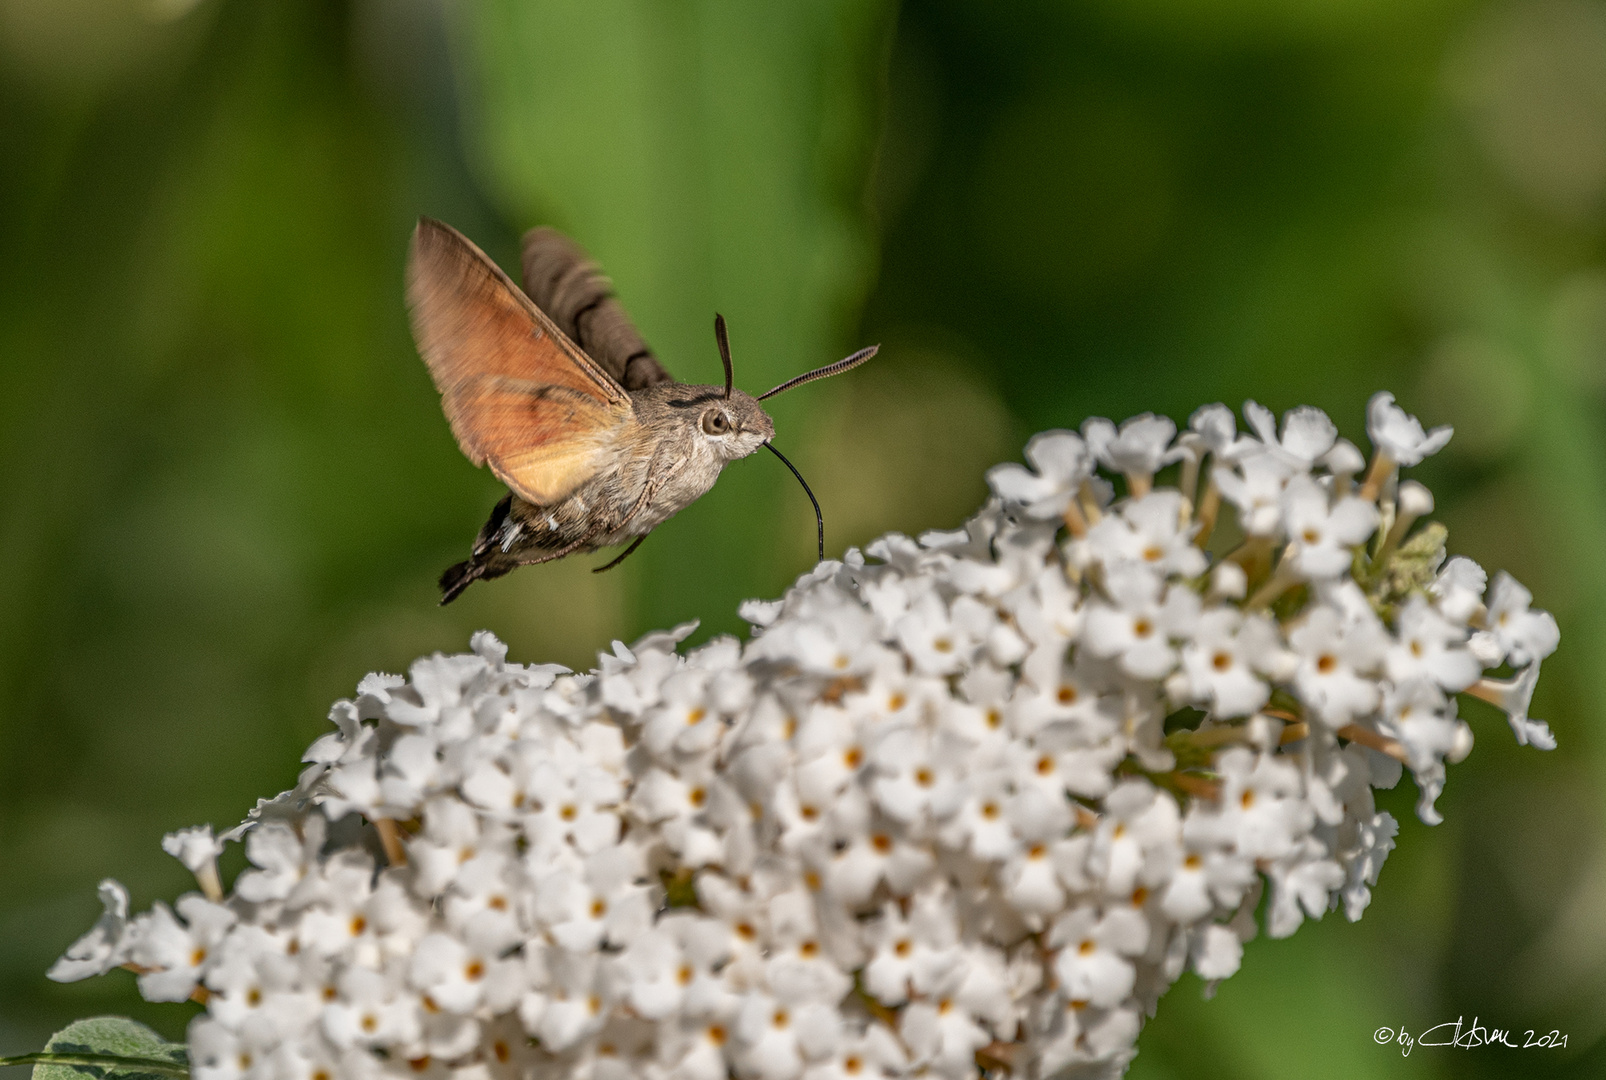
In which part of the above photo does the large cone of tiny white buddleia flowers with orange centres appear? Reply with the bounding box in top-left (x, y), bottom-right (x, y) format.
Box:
top-left (51, 394), bottom-right (1558, 1080)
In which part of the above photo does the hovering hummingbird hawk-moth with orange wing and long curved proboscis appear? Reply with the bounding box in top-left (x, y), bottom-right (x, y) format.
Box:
top-left (406, 217), bottom-right (877, 604)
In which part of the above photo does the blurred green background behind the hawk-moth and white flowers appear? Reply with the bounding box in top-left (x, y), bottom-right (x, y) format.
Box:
top-left (0, 0), bottom-right (1606, 1080)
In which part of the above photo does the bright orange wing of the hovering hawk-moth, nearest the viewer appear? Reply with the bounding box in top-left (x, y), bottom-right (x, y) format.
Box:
top-left (408, 219), bottom-right (636, 505)
